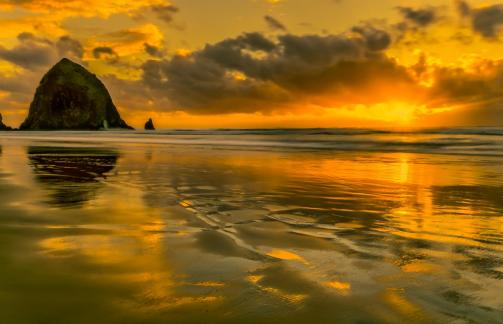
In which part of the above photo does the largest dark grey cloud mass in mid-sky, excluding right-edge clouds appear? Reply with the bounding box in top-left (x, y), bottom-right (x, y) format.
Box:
top-left (143, 27), bottom-right (410, 113)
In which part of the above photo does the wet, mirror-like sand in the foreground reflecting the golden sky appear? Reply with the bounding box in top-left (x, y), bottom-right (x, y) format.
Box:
top-left (0, 141), bottom-right (503, 323)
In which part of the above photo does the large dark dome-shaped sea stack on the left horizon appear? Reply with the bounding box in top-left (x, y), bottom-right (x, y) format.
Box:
top-left (20, 58), bottom-right (132, 130)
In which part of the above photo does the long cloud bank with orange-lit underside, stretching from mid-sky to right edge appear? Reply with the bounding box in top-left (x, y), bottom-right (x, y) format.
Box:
top-left (137, 24), bottom-right (503, 121)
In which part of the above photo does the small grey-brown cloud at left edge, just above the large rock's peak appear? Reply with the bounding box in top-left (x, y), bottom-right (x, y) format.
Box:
top-left (0, 33), bottom-right (83, 70)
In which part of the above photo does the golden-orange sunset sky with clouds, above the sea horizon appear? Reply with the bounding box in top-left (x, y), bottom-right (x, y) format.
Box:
top-left (0, 0), bottom-right (503, 128)
